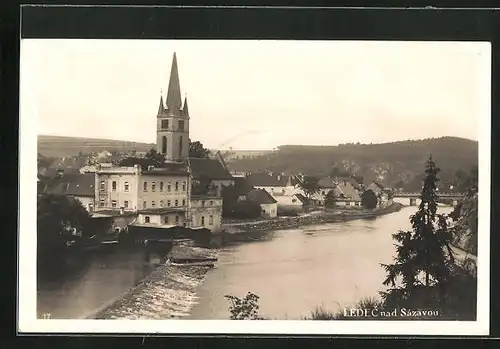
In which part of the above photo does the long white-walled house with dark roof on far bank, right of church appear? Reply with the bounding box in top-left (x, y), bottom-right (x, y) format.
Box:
top-left (246, 172), bottom-right (300, 196)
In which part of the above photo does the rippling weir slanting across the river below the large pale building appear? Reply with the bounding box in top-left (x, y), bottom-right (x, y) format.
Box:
top-left (86, 245), bottom-right (217, 319)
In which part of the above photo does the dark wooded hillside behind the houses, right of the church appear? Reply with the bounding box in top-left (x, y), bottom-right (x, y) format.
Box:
top-left (228, 137), bottom-right (478, 190)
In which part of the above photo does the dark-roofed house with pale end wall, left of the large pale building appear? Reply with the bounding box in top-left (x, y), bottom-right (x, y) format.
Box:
top-left (38, 170), bottom-right (95, 212)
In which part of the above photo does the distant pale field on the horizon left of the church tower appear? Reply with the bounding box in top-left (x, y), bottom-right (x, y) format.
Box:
top-left (38, 135), bottom-right (154, 157)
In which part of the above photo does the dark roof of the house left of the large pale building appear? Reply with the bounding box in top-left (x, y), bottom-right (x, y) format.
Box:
top-left (42, 173), bottom-right (95, 197)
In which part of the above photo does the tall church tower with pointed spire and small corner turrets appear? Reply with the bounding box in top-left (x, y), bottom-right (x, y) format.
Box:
top-left (156, 52), bottom-right (189, 161)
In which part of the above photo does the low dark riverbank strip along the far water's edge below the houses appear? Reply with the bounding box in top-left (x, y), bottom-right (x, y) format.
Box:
top-left (222, 202), bottom-right (404, 242)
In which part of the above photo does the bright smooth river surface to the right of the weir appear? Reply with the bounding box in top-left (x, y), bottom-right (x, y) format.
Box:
top-left (191, 207), bottom-right (451, 319)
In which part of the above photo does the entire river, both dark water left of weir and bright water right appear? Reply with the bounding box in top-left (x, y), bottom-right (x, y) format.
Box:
top-left (38, 207), bottom-right (451, 319)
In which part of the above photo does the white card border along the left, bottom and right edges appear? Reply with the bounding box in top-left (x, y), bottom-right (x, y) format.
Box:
top-left (18, 41), bottom-right (491, 335)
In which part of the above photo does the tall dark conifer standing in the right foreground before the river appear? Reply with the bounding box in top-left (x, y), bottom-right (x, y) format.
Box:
top-left (382, 156), bottom-right (454, 299)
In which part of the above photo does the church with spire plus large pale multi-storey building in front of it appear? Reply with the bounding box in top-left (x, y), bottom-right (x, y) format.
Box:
top-left (94, 53), bottom-right (230, 232)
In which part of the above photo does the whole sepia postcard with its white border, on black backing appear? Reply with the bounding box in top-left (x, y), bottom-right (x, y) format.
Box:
top-left (18, 39), bottom-right (491, 335)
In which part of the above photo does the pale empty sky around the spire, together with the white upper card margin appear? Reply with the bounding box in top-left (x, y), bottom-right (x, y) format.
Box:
top-left (21, 39), bottom-right (490, 150)
